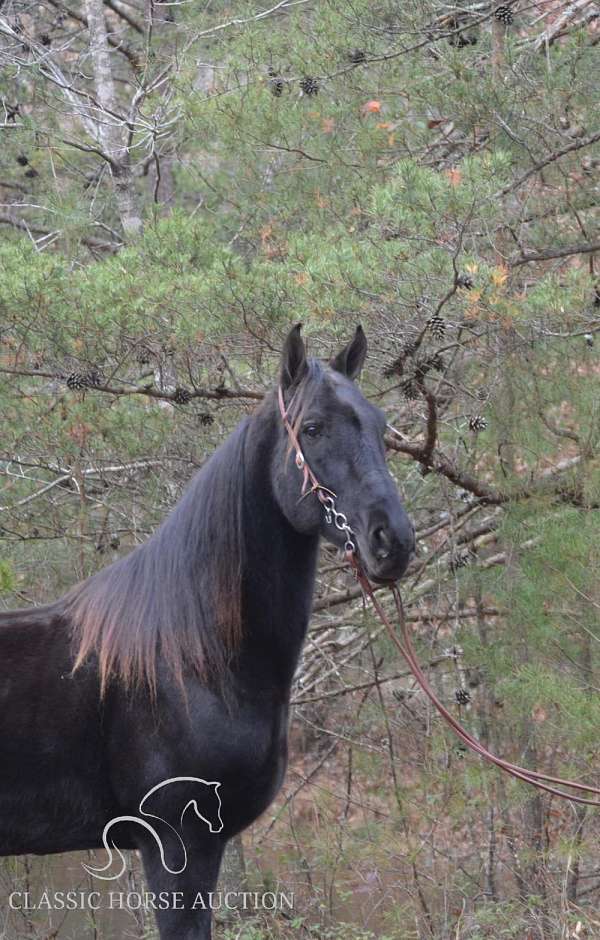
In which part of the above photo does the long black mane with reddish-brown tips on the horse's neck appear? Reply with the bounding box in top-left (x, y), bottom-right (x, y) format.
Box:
top-left (61, 418), bottom-right (250, 694)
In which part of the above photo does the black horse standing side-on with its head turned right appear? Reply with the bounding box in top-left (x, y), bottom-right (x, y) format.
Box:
top-left (0, 326), bottom-right (414, 940)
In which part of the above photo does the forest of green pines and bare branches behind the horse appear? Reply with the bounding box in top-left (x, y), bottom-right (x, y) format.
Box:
top-left (0, 0), bottom-right (600, 940)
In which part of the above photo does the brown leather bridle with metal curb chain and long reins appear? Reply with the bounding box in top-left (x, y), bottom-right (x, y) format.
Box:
top-left (278, 386), bottom-right (600, 806)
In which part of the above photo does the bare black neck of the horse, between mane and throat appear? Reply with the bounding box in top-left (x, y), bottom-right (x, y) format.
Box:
top-left (240, 415), bottom-right (319, 691)
